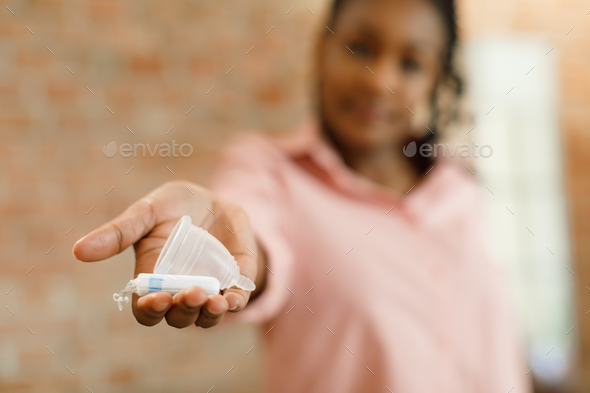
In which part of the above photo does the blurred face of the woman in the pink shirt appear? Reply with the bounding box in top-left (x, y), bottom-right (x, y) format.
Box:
top-left (318, 0), bottom-right (447, 150)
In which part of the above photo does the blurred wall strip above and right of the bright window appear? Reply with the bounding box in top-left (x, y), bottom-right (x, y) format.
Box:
top-left (460, 0), bottom-right (590, 392)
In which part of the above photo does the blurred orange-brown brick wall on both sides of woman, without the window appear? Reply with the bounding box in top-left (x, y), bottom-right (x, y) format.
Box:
top-left (0, 0), bottom-right (590, 392)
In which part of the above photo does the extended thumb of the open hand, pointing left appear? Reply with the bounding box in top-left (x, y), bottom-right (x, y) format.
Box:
top-left (72, 197), bottom-right (157, 262)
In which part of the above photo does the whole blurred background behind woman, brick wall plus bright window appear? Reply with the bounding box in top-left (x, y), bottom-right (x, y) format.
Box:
top-left (0, 0), bottom-right (590, 393)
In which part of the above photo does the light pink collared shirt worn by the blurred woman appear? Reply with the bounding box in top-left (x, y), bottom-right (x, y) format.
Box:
top-left (209, 119), bottom-right (531, 393)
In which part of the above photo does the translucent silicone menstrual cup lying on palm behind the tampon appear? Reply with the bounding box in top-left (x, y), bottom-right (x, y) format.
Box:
top-left (154, 216), bottom-right (256, 291)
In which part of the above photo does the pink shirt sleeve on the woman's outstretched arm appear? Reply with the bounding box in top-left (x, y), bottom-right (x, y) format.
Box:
top-left (207, 132), bottom-right (294, 324)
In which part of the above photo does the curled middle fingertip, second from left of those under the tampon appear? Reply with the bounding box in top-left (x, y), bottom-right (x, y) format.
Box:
top-left (166, 287), bottom-right (207, 329)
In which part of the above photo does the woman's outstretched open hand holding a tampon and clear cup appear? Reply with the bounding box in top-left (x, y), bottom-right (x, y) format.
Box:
top-left (72, 181), bottom-right (259, 328)
